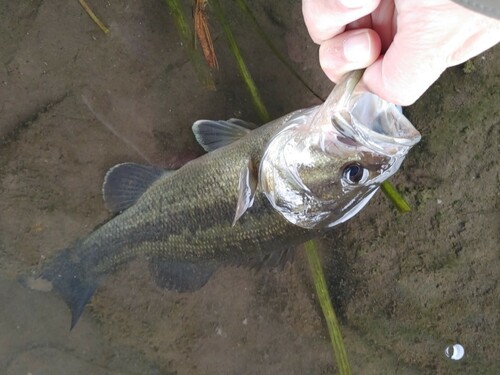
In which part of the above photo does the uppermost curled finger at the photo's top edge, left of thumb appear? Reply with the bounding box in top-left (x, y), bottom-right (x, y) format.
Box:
top-left (302, 0), bottom-right (380, 44)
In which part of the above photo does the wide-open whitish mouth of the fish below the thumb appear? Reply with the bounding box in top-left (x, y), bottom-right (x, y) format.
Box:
top-left (331, 91), bottom-right (421, 156)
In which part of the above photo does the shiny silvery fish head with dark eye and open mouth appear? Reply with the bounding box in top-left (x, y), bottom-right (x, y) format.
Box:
top-left (259, 84), bottom-right (420, 229)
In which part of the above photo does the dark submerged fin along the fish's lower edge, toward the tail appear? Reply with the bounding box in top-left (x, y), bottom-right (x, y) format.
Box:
top-left (150, 257), bottom-right (218, 293)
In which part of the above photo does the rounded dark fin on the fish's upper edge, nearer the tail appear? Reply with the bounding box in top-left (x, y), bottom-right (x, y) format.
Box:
top-left (102, 163), bottom-right (169, 214)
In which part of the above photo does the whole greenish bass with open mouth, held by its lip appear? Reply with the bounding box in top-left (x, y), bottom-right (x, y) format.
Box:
top-left (33, 72), bottom-right (420, 328)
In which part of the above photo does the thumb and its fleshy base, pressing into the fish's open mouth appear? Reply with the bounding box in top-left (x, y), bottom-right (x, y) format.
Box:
top-left (363, 1), bottom-right (500, 105)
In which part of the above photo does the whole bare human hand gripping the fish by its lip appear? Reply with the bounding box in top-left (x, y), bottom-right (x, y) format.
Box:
top-left (302, 0), bottom-right (500, 105)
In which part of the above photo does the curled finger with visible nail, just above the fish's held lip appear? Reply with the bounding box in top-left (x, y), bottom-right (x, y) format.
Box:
top-left (319, 29), bottom-right (381, 82)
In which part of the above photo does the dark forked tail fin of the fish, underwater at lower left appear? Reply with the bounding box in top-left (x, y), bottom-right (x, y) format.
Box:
top-left (40, 247), bottom-right (99, 329)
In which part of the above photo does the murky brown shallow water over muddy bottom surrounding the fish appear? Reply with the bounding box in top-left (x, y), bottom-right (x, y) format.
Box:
top-left (0, 0), bottom-right (500, 375)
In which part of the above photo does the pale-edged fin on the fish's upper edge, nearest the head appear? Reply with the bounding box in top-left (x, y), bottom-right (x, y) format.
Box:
top-left (192, 118), bottom-right (256, 152)
